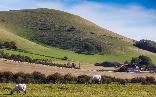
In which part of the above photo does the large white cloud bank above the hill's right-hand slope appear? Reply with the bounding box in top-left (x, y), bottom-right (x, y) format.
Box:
top-left (68, 2), bottom-right (156, 41)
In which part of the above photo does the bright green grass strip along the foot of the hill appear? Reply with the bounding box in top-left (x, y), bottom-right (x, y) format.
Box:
top-left (0, 28), bottom-right (156, 64)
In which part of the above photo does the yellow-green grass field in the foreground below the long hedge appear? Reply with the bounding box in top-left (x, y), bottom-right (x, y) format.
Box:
top-left (0, 83), bottom-right (156, 97)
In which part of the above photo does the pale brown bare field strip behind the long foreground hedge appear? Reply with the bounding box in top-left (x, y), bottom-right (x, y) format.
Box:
top-left (0, 59), bottom-right (156, 78)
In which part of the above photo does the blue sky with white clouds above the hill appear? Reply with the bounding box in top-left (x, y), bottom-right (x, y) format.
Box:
top-left (0, 0), bottom-right (156, 41)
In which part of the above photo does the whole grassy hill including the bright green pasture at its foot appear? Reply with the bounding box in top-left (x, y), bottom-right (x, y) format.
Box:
top-left (0, 9), bottom-right (156, 63)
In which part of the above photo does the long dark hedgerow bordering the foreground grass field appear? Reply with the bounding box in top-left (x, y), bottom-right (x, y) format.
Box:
top-left (0, 72), bottom-right (156, 85)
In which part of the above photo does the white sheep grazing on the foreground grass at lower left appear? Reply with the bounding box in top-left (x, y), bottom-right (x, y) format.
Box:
top-left (11, 84), bottom-right (26, 94)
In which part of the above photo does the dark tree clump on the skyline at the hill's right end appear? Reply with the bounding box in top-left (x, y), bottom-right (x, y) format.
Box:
top-left (134, 39), bottom-right (156, 53)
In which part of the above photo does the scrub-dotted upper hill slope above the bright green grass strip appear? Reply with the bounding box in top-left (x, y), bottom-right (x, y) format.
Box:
top-left (0, 9), bottom-right (132, 54)
